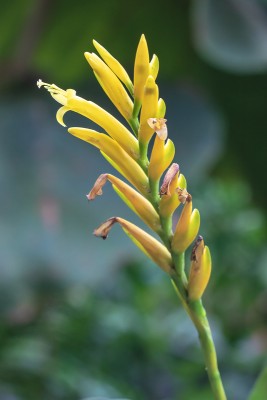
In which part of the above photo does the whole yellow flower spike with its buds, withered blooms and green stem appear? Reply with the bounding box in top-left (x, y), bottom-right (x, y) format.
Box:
top-left (37, 35), bottom-right (228, 399)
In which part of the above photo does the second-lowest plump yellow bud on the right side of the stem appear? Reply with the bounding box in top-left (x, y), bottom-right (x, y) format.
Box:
top-left (172, 193), bottom-right (200, 253)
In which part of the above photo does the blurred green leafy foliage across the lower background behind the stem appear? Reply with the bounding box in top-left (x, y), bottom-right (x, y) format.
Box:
top-left (0, 181), bottom-right (267, 400)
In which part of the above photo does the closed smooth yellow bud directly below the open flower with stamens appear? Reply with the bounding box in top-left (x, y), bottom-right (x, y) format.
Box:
top-left (69, 128), bottom-right (148, 196)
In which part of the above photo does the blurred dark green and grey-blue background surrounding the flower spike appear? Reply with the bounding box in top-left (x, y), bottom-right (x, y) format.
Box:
top-left (0, 0), bottom-right (267, 400)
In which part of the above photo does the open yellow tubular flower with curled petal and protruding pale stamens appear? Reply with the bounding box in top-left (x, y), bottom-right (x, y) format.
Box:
top-left (37, 79), bottom-right (139, 159)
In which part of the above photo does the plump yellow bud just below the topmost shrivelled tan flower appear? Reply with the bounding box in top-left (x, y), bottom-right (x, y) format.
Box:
top-left (148, 136), bottom-right (175, 182)
